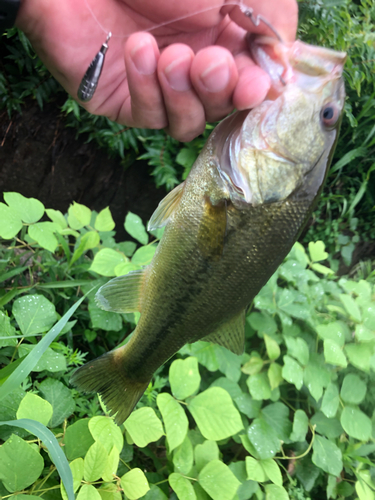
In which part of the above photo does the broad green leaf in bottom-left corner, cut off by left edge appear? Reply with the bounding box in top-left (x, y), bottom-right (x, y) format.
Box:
top-left (0, 434), bottom-right (44, 492)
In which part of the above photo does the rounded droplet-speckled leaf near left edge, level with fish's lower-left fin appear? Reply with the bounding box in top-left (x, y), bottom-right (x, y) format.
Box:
top-left (12, 295), bottom-right (57, 335)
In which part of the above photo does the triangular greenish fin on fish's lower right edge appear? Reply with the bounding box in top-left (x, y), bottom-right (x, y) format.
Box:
top-left (202, 311), bottom-right (245, 354)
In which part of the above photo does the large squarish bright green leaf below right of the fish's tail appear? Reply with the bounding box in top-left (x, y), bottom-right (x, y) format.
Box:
top-left (188, 387), bottom-right (243, 441)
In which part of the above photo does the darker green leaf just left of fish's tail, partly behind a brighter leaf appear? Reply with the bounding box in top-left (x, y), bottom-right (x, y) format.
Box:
top-left (38, 378), bottom-right (76, 428)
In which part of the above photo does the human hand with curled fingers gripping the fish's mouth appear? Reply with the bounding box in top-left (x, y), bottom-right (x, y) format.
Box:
top-left (16, 0), bottom-right (298, 141)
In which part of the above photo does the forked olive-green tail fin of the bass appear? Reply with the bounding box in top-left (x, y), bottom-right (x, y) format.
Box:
top-left (70, 346), bottom-right (150, 425)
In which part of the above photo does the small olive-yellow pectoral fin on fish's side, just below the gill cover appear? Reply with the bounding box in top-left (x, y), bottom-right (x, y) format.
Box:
top-left (198, 198), bottom-right (227, 260)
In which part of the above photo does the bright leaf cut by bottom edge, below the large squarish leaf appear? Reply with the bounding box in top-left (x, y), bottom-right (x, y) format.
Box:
top-left (198, 460), bottom-right (241, 500)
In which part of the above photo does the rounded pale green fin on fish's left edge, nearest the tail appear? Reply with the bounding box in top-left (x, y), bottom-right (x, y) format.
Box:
top-left (95, 269), bottom-right (145, 313)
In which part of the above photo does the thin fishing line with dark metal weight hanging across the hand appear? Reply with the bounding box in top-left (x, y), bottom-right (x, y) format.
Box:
top-left (77, 0), bottom-right (283, 102)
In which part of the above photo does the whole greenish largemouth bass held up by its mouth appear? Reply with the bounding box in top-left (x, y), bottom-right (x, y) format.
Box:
top-left (71, 38), bottom-right (346, 424)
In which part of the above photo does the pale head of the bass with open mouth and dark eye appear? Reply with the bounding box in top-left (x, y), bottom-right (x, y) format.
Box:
top-left (217, 37), bottom-right (346, 205)
